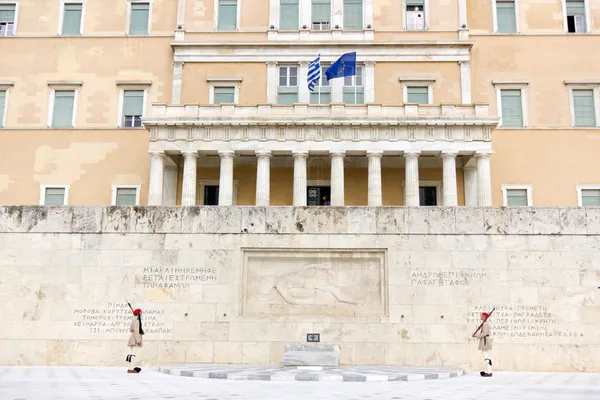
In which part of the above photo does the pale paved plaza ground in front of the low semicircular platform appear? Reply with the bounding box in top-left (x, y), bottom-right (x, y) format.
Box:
top-left (0, 367), bottom-right (600, 400)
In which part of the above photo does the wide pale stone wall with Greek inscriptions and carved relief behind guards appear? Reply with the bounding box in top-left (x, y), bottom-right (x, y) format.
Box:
top-left (0, 207), bottom-right (600, 371)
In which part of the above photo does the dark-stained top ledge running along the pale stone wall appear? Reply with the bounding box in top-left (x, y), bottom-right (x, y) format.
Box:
top-left (0, 206), bottom-right (600, 235)
